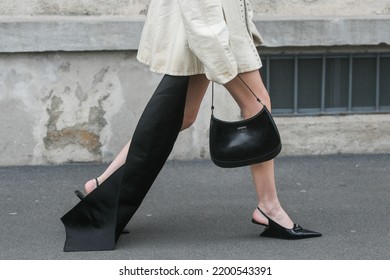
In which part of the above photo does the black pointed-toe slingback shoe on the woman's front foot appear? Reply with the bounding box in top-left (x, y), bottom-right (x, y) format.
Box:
top-left (258, 208), bottom-right (322, 239)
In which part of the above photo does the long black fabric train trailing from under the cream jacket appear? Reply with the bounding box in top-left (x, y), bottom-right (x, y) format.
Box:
top-left (61, 75), bottom-right (189, 252)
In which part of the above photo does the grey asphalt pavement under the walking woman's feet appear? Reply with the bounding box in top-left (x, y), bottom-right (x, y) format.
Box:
top-left (0, 155), bottom-right (390, 260)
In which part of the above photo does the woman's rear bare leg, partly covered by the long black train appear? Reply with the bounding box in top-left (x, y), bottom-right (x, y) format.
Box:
top-left (84, 75), bottom-right (209, 194)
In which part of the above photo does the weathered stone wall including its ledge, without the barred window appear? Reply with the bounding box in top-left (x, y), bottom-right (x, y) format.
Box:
top-left (0, 0), bottom-right (390, 165)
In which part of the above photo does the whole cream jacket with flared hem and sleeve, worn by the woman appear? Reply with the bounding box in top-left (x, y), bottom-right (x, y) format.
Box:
top-left (137, 0), bottom-right (262, 84)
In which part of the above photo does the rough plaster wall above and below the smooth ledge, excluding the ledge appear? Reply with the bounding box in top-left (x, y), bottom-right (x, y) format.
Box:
top-left (0, 0), bottom-right (390, 165)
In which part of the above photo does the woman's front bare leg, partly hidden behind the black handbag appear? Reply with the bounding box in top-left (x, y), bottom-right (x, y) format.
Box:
top-left (225, 71), bottom-right (293, 228)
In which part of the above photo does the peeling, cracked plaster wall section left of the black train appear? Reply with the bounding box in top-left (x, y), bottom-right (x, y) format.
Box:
top-left (0, 52), bottom-right (163, 165)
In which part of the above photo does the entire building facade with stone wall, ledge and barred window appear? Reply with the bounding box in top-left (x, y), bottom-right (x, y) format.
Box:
top-left (0, 0), bottom-right (390, 165)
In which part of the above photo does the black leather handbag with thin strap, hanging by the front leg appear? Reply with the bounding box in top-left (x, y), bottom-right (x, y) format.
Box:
top-left (209, 76), bottom-right (282, 168)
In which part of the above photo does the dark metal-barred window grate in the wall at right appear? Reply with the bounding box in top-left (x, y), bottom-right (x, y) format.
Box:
top-left (261, 53), bottom-right (390, 115)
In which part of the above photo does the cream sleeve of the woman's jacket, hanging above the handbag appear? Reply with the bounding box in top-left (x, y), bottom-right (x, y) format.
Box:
top-left (177, 0), bottom-right (237, 84)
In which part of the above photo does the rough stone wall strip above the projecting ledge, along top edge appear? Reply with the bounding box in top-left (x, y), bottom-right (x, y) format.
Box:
top-left (0, 0), bottom-right (390, 16)
